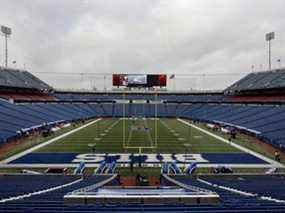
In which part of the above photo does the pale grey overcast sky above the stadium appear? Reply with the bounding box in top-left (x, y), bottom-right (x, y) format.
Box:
top-left (0, 0), bottom-right (285, 89)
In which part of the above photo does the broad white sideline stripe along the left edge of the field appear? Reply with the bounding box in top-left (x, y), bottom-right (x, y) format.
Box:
top-left (0, 118), bottom-right (101, 165)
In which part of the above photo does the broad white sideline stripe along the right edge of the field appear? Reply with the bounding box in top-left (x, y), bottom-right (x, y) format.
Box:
top-left (177, 118), bottom-right (284, 168)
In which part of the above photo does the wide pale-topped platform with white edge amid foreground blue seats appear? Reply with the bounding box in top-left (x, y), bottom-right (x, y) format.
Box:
top-left (64, 186), bottom-right (219, 204)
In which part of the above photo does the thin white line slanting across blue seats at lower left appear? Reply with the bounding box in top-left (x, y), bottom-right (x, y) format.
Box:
top-left (0, 178), bottom-right (83, 203)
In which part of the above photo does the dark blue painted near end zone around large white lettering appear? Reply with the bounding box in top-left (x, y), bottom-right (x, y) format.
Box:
top-left (10, 153), bottom-right (268, 164)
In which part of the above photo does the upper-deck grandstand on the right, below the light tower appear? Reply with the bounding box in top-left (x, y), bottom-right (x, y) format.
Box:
top-left (224, 68), bottom-right (285, 94)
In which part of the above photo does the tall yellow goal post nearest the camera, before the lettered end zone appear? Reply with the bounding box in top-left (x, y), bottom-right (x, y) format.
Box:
top-left (122, 93), bottom-right (159, 153)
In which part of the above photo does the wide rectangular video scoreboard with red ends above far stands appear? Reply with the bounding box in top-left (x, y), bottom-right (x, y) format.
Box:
top-left (113, 74), bottom-right (167, 87)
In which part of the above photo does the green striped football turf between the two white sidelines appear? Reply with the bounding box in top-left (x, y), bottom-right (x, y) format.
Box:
top-left (37, 118), bottom-right (241, 153)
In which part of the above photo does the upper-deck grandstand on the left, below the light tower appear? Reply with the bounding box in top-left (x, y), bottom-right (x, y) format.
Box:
top-left (0, 67), bottom-right (52, 90)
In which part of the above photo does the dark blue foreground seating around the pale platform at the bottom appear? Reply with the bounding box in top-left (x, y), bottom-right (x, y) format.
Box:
top-left (0, 175), bottom-right (285, 213)
